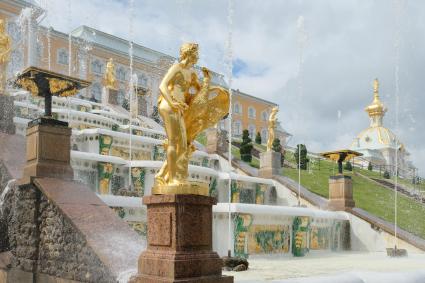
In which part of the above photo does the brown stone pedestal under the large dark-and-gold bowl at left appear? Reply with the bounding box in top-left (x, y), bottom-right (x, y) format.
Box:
top-left (20, 118), bottom-right (74, 184)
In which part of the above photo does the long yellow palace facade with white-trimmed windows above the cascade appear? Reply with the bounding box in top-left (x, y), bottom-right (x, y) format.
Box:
top-left (0, 0), bottom-right (290, 145)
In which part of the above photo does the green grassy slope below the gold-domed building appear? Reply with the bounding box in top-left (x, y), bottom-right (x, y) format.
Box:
top-left (238, 147), bottom-right (425, 241)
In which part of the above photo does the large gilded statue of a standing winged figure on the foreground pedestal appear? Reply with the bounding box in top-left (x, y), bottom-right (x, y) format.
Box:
top-left (153, 43), bottom-right (230, 194)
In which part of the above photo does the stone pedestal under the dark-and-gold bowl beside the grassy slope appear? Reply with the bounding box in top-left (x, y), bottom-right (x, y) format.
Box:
top-left (328, 175), bottom-right (355, 211)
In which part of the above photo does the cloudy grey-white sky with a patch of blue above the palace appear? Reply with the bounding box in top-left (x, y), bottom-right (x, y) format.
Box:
top-left (39, 0), bottom-right (425, 177)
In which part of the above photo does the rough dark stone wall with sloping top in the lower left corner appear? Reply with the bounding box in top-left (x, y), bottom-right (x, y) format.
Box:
top-left (0, 181), bottom-right (127, 282)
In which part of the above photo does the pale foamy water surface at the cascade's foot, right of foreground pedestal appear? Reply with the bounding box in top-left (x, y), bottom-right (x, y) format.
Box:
top-left (224, 252), bottom-right (425, 283)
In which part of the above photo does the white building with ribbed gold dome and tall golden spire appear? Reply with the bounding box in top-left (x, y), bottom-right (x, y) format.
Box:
top-left (350, 79), bottom-right (415, 176)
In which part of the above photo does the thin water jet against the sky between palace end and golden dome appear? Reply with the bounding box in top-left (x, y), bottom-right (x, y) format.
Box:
top-left (297, 16), bottom-right (307, 206)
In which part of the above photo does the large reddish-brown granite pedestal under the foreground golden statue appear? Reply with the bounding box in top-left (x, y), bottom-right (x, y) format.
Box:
top-left (130, 195), bottom-right (233, 283)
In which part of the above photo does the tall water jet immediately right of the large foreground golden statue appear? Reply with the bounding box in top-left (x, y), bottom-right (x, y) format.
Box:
top-left (225, 0), bottom-right (234, 256)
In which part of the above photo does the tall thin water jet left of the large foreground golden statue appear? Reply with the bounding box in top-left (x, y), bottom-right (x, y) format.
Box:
top-left (128, 0), bottom-right (134, 191)
